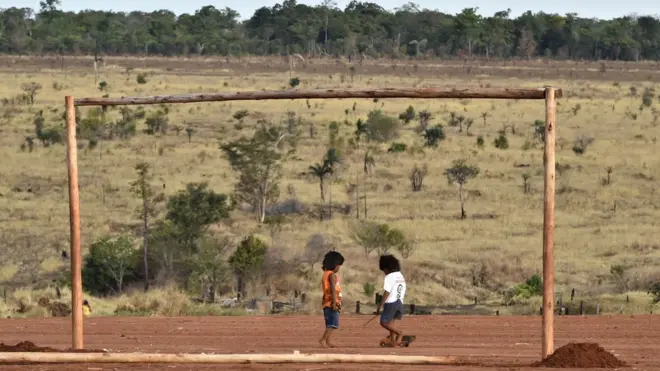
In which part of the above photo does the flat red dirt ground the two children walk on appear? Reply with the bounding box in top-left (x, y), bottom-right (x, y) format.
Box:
top-left (0, 315), bottom-right (660, 371)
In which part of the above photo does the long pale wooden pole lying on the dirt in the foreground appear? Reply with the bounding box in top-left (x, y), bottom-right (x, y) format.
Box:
top-left (0, 352), bottom-right (456, 365)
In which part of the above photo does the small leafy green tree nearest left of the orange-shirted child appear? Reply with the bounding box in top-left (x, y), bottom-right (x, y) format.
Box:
top-left (229, 235), bottom-right (268, 297)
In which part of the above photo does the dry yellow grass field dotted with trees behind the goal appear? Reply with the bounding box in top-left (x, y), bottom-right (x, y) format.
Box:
top-left (0, 57), bottom-right (660, 313)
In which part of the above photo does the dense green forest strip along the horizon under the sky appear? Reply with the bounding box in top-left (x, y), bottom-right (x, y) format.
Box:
top-left (0, 0), bottom-right (660, 61)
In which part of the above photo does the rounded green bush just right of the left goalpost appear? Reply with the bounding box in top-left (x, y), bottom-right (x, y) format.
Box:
top-left (82, 236), bottom-right (136, 295)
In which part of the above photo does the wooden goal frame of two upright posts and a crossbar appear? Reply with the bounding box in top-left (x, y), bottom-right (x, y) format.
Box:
top-left (58, 87), bottom-right (563, 363)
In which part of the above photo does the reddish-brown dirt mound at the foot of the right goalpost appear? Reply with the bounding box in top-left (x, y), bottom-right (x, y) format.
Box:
top-left (532, 343), bottom-right (629, 368)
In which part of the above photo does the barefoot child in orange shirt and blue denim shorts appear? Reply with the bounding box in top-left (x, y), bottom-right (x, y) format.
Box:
top-left (319, 251), bottom-right (344, 348)
